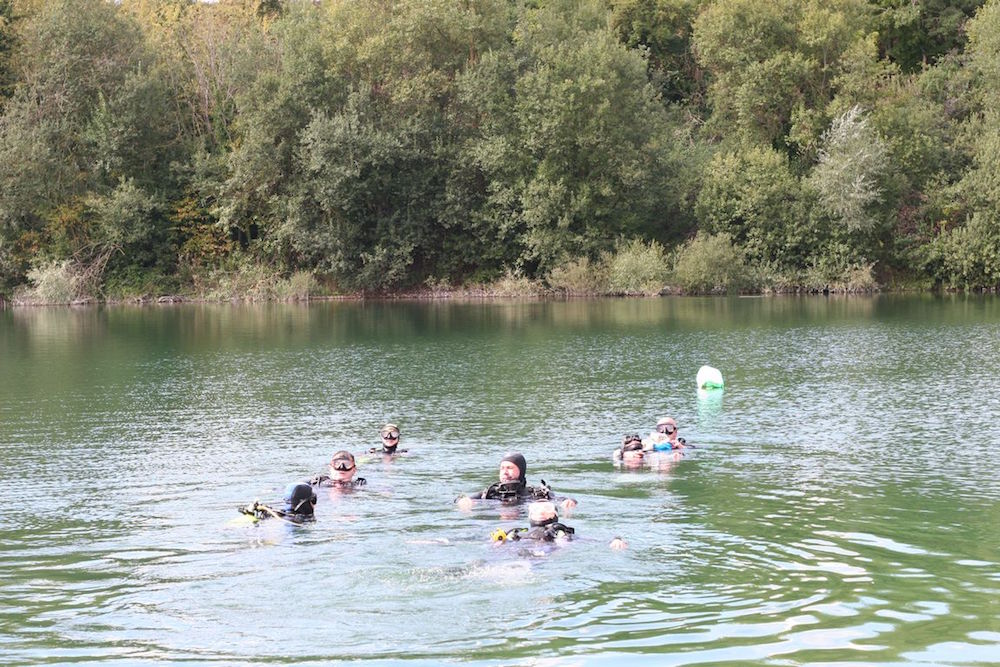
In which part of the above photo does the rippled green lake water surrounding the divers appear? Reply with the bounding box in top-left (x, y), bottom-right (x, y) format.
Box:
top-left (0, 296), bottom-right (1000, 665)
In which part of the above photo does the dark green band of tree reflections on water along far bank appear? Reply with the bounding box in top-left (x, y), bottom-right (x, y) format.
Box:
top-left (17, 295), bottom-right (1000, 353)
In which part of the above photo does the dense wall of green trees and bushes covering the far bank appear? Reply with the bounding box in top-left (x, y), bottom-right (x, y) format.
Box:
top-left (0, 0), bottom-right (1000, 300)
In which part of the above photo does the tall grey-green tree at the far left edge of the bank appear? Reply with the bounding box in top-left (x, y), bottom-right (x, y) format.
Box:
top-left (0, 0), bottom-right (172, 290)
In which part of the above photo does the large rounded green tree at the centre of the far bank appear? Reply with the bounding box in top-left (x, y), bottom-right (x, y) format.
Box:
top-left (466, 2), bottom-right (667, 272)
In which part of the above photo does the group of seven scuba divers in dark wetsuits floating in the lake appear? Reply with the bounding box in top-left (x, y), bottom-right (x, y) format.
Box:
top-left (238, 417), bottom-right (693, 550)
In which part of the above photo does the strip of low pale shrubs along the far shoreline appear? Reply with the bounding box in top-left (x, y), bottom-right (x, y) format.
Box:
top-left (0, 234), bottom-right (926, 306)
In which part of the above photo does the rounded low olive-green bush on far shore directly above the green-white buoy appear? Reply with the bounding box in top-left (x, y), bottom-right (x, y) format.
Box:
top-left (674, 232), bottom-right (752, 292)
